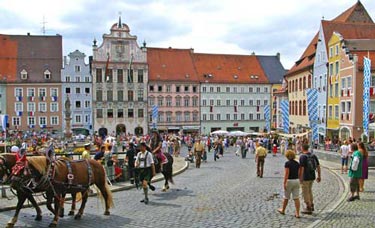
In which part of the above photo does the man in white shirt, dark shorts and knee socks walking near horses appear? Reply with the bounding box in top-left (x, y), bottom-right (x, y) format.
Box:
top-left (135, 142), bottom-right (155, 204)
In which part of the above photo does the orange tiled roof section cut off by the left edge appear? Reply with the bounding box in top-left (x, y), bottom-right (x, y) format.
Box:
top-left (0, 34), bottom-right (18, 81)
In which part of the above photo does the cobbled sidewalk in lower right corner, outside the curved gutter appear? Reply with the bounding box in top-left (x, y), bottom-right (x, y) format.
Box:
top-left (311, 159), bottom-right (375, 227)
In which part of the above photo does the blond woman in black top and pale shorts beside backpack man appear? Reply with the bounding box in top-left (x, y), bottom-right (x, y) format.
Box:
top-left (277, 150), bottom-right (300, 218)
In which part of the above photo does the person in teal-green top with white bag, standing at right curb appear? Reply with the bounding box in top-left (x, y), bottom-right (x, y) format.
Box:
top-left (348, 143), bottom-right (363, 202)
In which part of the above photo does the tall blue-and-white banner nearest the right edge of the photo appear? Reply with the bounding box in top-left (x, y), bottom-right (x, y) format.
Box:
top-left (363, 57), bottom-right (371, 137)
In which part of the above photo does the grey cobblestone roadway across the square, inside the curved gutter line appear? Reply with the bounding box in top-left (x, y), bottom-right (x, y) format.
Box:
top-left (0, 148), bottom-right (344, 228)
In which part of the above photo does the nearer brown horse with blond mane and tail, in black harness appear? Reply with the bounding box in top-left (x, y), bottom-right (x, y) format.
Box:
top-left (12, 156), bottom-right (113, 227)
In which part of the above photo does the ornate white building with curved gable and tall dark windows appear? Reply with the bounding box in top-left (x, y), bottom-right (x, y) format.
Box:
top-left (91, 18), bottom-right (148, 136)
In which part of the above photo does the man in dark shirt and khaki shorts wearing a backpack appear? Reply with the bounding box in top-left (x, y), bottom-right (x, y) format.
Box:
top-left (299, 144), bottom-right (321, 215)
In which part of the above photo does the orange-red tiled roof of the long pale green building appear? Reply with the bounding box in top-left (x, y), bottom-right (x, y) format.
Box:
top-left (193, 53), bottom-right (269, 84)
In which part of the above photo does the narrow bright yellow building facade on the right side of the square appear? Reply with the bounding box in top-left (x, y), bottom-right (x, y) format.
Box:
top-left (327, 33), bottom-right (341, 134)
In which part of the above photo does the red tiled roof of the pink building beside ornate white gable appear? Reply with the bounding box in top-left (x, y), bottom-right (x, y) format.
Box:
top-left (147, 48), bottom-right (198, 82)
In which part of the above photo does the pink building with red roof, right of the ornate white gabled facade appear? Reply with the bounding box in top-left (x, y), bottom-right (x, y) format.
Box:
top-left (147, 48), bottom-right (200, 134)
